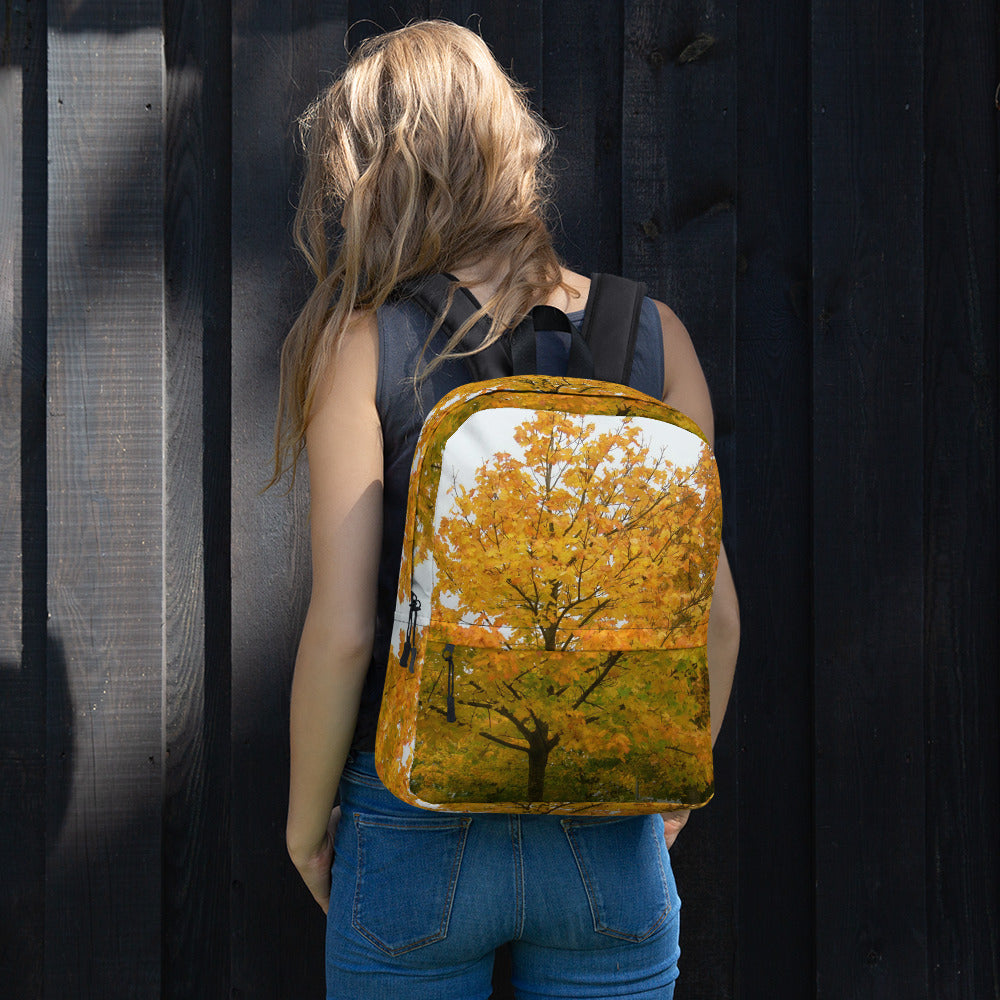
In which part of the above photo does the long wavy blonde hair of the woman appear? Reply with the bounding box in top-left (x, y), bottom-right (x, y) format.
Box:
top-left (268, 15), bottom-right (562, 485)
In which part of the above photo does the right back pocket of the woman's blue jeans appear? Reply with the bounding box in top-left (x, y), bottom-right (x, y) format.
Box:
top-left (562, 816), bottom-right (672, 941)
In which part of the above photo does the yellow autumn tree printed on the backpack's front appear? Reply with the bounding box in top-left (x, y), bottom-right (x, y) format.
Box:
top-left (413, 412), bottom-right (720, 801)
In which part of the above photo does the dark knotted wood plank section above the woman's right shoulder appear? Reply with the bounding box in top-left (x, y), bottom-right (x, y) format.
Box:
top-left (622, 0), bottom-right (736, 390)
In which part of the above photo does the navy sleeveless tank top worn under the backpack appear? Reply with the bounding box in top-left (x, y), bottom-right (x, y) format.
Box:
top-left (353, 290), bottom-right (663, 751)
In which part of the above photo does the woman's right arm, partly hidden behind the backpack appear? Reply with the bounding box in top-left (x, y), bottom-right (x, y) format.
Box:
top-left (656, 302), bottom-right (740, 847)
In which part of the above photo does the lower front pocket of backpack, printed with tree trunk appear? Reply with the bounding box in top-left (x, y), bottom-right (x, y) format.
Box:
top-left (409, 629), bottom-right (712, 812)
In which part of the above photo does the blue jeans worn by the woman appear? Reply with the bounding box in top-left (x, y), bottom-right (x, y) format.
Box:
top-left (326, 753), bottom-right (680, 1000)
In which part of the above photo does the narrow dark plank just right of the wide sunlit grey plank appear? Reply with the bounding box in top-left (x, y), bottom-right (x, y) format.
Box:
top-left (161, 0), bottom-right (231, 1000)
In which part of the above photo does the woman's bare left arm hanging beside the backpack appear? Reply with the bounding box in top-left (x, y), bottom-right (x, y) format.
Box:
top-left (286, 314), bottom-right (382, 911)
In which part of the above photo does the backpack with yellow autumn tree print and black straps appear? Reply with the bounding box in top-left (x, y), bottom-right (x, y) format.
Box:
top-left (375, 275), bottom-right (722, 814)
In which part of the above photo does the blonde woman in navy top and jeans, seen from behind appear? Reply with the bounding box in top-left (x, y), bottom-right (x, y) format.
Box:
top-left (276, 22), bottom-right (739, 1000)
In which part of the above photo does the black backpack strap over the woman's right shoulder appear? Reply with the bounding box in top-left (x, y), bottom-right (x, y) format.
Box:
top-left (581, 274), bottom-right (646, 385)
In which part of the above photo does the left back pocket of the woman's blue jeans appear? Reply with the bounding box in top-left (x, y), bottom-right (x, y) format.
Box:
top-left (352, 813), bottom-right (472, 955)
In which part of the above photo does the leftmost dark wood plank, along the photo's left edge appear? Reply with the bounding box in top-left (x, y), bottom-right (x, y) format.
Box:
top-left (0, 10), bottom-right (46, 998)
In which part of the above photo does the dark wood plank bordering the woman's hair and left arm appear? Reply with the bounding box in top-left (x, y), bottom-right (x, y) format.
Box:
top-left (232, 0), bottom-right (347, 1000)
